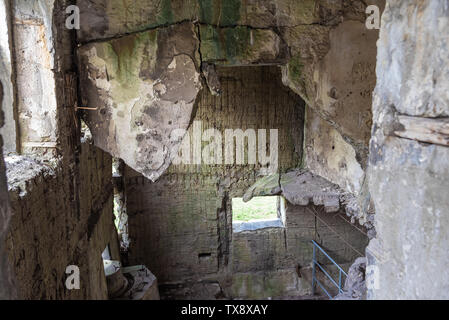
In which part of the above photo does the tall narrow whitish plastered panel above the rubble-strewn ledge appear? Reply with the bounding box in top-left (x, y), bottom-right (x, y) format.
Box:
top-left (12, 0), bottom-right (59, 152)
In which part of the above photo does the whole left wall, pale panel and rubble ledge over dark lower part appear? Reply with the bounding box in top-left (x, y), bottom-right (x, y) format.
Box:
top-left (1, 0), bottom-right (120, 299)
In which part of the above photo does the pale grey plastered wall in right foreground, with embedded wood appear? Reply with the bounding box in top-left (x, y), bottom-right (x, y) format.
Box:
top-left (367, 0), bottom-right (449, 299)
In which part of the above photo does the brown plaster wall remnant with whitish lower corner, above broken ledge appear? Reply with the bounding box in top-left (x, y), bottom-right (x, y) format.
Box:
top-left (300, 17), bottom-right (382, 195)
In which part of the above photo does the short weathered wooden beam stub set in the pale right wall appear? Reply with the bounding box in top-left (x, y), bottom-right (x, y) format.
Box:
top-left (394, 116), bottom-right (449, 147)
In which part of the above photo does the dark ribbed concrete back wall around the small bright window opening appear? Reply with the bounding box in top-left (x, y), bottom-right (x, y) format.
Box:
top-left (125, 67), bottom-right (366, 299)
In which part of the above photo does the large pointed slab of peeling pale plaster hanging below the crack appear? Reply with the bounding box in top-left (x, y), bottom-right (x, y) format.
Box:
top-left (78, 23), bottom-right (201, 180)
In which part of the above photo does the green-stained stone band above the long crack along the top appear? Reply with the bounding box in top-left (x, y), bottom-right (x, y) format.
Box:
top-left (78, 0), bottom-right (322, 42)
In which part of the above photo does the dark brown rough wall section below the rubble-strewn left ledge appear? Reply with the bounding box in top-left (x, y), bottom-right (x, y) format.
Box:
top-left (6, 143), bottom-right (119, 299)
